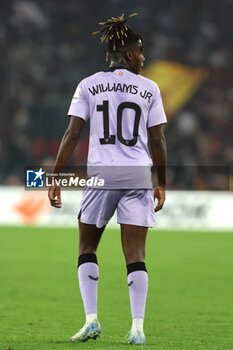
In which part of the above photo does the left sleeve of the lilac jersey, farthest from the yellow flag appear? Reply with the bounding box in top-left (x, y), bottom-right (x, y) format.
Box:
top-left (67, 80), bottom-right (89, 121)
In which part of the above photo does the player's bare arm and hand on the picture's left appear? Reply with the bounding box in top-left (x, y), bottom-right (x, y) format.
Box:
top-left (48, 116), bottom-right (85, 208)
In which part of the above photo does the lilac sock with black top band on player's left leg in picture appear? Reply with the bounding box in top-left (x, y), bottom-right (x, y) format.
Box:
top-left (78, 254), bottom-right (99, 315)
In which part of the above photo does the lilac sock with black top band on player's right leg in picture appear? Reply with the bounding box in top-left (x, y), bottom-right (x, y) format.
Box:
top-left (127, 262), bottom-right (148, 319)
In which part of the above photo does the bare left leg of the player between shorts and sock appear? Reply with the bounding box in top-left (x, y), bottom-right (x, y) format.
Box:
top-left (79, 219), bottom-right (105, 255)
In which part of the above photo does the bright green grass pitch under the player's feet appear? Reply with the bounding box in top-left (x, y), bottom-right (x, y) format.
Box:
top-left (0, 227), bottom-right (233, 350)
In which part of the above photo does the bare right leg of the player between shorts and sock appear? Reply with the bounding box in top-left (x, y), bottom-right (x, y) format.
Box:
top-left (121, 224), bottom-right (148, 264)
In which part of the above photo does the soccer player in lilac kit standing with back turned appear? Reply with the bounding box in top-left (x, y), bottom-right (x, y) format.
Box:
top-left (48, 14), bottom-right (166, 344)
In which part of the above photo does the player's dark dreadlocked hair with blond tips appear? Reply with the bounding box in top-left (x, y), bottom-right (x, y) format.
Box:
top-left (92, 13), bottom-right (143, 61)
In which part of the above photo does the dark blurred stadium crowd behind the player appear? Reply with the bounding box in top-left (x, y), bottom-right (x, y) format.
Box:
top-left (0, 0), bottom-right (233, 189)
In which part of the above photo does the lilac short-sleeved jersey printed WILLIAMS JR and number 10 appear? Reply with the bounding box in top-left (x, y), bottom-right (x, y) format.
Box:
top-left (68, 68), bottom-right (167, 188)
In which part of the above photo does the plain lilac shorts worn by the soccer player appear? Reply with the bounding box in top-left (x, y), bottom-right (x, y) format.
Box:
top-left (79, 189), bottom-right (155, 228)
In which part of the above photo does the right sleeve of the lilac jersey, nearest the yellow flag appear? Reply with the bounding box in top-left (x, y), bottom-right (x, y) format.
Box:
top-left (147, 84), bottom-right (167, 128)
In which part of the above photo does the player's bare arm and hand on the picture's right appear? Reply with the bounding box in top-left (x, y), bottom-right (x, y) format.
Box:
top-left (148, 124), bottom-right (167, 212)
